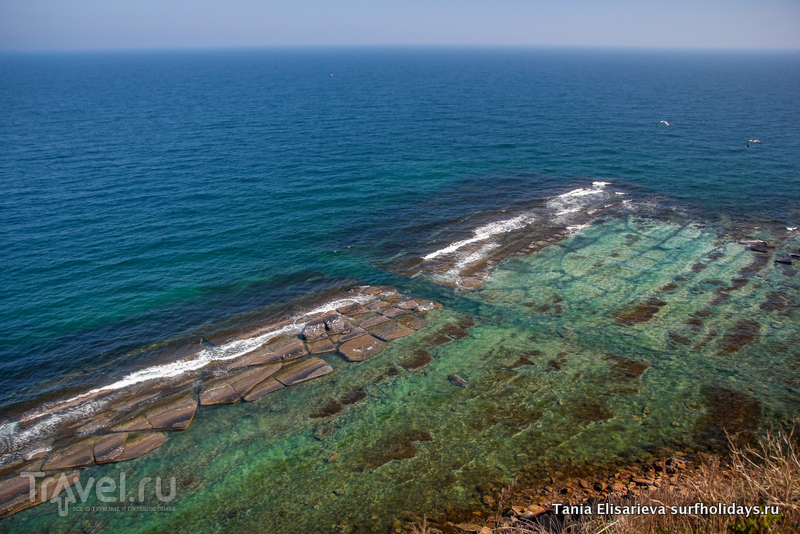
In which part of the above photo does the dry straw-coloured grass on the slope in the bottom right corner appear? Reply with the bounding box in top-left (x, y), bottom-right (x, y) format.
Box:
top-left (494, 430), bottom-right (800, 534)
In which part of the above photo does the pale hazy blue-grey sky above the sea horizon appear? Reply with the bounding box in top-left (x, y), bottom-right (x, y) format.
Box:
top-left (0, 0), bottom-right (800, 51)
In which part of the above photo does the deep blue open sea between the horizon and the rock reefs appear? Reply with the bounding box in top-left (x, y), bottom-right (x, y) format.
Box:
top-left (0, 49), bottom-right (800, 420)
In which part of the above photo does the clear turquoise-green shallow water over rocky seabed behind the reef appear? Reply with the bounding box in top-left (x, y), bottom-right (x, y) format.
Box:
top-left (3, 206), bottom-right (800, 533)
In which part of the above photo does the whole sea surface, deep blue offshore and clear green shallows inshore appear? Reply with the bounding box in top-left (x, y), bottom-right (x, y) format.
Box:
top-left (0, 48), bottom-right (800, 532)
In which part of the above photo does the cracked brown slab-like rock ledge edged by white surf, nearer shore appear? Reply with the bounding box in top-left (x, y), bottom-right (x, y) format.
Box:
top-left (0, 286), bottom-right (441, 518)
